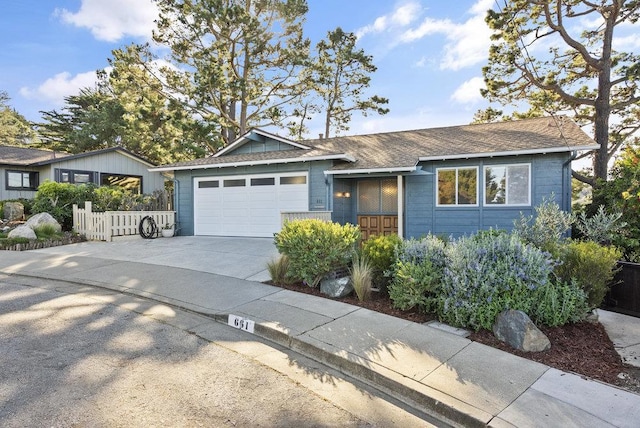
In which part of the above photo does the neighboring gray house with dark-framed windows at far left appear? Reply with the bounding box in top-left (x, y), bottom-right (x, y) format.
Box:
top-left (0, 146), bottom-right (165, 200)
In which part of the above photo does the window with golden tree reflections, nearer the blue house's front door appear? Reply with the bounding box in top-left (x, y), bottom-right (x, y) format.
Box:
top-left (437, 167), bottom-right (478, 206)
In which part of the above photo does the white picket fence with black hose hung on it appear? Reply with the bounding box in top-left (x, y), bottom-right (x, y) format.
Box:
top-left (73, 201), bottom-right (176, 242)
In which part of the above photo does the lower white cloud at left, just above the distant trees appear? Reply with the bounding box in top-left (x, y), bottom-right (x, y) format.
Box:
top-left (20, 71), bottom-right (97, 106)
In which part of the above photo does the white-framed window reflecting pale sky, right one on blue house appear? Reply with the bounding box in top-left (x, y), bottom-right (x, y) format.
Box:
top-left (484, 164), bottom-right (531, 205)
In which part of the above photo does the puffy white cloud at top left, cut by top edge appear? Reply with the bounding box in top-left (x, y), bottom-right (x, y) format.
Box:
top-left (56, 0), bottom-right (158, 42)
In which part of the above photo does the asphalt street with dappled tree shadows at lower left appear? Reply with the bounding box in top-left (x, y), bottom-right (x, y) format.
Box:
top-left (0, 280), bottom-right (427, 428)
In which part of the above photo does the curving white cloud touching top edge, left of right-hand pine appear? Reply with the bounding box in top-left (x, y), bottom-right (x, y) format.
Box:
top-left (398, 0), bottom-right (494, 70)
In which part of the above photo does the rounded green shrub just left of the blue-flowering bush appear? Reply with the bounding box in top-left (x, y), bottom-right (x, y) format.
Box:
top-left (389, 259), bottom-right (442, 311)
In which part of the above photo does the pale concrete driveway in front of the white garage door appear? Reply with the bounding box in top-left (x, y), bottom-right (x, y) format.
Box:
top-left (32, 236), bottom-right (278, 282)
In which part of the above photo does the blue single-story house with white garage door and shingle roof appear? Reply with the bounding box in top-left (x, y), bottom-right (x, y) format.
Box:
top-left (152, 117), bottom-right (598, 238)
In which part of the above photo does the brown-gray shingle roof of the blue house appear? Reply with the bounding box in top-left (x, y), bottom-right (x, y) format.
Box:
top-left (152, 117), bottom-right (597, 171)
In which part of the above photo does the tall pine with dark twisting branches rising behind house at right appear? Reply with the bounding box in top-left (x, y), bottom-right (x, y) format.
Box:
top-left (482, 0), bottom-right (640, 181)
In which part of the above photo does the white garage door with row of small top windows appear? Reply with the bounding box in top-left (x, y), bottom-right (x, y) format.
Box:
top-left (193, 172), bottom-right (309, 237)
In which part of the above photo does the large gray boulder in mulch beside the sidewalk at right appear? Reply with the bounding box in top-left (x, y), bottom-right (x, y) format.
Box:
top-left (493, 310), bottom-right (551, 352)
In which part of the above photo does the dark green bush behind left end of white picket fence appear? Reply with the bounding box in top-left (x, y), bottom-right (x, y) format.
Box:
top-left (32, 181), bottom-right (95, 230)
